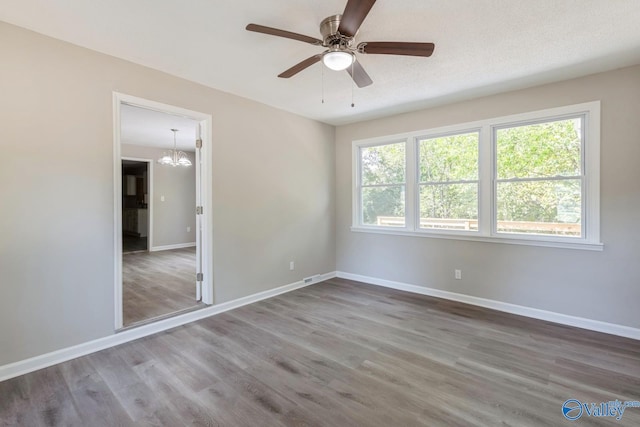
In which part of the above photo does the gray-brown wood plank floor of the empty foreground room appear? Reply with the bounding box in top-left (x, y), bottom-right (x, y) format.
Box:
top-left (0, 279), bottom-right (640, 427)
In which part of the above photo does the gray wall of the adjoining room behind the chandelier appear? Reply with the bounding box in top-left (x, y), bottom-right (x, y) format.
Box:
top-left (121, 144), bottom-right (196, 248)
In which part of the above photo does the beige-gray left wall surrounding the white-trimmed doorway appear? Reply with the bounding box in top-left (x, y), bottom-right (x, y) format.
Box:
top-left (0, 23), bottom-right (335, 365)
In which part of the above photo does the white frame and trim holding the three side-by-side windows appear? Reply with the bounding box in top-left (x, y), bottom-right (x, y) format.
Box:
top-left (351, 101), bottom-right (604, 251)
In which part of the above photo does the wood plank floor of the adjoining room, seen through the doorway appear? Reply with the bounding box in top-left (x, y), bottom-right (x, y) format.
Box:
top-left (122, 248), bottom-right (203, 326)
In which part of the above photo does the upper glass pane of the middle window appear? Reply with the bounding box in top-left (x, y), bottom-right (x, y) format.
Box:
top-left (418, 132), bottom-right (479, 182)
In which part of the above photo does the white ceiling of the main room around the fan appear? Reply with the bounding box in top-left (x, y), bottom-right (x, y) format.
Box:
top-left (0, 0), bottom-right (640, 124)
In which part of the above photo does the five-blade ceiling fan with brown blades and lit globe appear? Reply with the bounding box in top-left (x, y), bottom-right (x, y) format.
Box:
top-left (246, 0), bottom-right (435, 87)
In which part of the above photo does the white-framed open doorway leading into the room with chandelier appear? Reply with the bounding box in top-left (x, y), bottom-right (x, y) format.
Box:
top-left (114, 93), bottom-right (213, 330)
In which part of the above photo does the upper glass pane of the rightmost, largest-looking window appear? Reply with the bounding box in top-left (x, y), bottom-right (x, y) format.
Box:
top-left (496, 119), bottom-right (582, 179)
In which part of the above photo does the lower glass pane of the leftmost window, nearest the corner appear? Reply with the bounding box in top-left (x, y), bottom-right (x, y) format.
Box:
top-left (362, 185), bottom-right (405, 227)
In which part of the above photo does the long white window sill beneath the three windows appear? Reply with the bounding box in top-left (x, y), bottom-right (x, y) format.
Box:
top-left (351, 226), bottom-right (604, 251)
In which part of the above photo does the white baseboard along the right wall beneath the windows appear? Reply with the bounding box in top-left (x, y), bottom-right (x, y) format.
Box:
top-left (337, 271), bottom-right (640, 340)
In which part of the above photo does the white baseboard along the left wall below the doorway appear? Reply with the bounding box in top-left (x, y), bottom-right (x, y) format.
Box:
top-left (0, 271), bottom-right (336, 381)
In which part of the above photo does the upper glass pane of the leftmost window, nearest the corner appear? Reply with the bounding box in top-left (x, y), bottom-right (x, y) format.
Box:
top-left (360, 142), bottom-right (406, 185)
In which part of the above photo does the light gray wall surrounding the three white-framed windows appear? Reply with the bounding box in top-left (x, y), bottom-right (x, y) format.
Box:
top-left (336, 66), bottom-right (640, 328)
